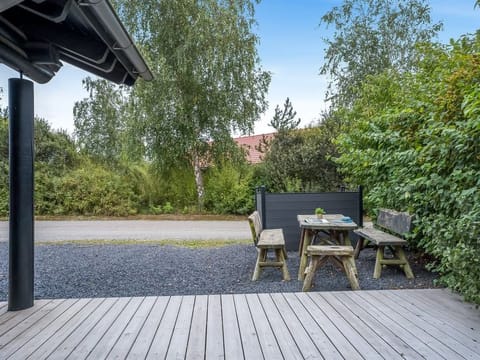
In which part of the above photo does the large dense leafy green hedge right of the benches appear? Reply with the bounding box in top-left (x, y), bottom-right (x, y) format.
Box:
top-left (338, 33), bottom-right (480, 304)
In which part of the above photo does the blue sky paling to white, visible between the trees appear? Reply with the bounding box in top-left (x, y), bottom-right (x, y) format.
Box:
top-left (0, 0), bottom-right (480, 134)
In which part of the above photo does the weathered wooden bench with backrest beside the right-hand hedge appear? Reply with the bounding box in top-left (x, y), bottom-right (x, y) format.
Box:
top-left (355, 209), bottom-right (414, 279)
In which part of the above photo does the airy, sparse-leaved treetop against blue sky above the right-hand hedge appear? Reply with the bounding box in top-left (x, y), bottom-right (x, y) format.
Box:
top-left (320, 0), bottom-right (442, 106)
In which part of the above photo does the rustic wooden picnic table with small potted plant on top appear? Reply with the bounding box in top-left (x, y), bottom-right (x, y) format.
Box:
top-left (297, 214), bottom-right (358, 281)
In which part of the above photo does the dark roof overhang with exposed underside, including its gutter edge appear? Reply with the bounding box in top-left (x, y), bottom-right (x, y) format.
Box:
top-left (0, 0), bottom-right (153, 85)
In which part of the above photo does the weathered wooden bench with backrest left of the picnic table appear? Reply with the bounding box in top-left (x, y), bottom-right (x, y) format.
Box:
top-left (248, 211), bottom-right (290, 281)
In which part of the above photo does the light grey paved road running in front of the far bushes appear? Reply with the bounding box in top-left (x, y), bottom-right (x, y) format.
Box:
top-left (0, 220), bottom-right (251, 242)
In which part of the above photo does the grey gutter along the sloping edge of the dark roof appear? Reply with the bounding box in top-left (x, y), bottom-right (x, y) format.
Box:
top-left (78, 0), bottom-right (153, 81)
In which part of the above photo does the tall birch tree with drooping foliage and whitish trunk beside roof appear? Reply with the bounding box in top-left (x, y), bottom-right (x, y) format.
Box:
top-left (116, 0), bottom-right (270, 207)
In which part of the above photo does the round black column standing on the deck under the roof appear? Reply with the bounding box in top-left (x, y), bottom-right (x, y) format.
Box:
top-left (8, 79), bottom-right (34, 311)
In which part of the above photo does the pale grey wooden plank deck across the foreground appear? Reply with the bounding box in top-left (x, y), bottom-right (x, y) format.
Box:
top-left (0, 289), bottom-right (480, 360)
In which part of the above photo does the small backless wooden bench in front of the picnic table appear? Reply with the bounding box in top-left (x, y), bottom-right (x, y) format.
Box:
top-left (302, 245), bottom-right (360, 291)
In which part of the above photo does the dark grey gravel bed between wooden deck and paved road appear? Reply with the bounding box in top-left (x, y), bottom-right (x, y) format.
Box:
top-left (0, 243), bottom-right (436, 301)
